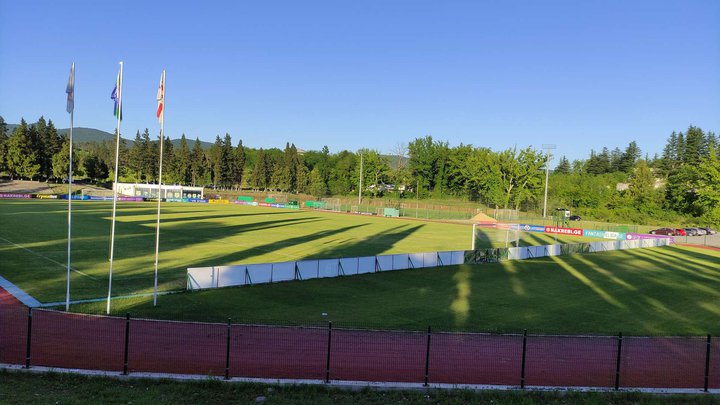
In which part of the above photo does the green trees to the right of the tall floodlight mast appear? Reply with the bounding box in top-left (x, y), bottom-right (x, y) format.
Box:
top-left (550, 126), bottom-right (720, 224)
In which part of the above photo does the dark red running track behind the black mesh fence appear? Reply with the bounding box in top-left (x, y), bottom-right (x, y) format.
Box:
top-left (0, 289), bottom-right (720, 389)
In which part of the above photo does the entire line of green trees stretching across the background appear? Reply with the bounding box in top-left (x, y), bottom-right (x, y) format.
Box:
top-left (0, 117), bottom-right (720, 223)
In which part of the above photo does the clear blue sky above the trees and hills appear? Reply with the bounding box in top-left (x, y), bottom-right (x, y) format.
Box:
top-left (0, 0), bottom-right (720, 158)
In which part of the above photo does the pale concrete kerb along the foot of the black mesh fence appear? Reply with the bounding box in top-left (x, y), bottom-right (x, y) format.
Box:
top-left (0, 363), bottom-right (720, 395)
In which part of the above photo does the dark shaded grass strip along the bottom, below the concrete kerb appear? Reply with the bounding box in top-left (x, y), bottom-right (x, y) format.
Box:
top-left (0, 371), bottom-right (720, 405)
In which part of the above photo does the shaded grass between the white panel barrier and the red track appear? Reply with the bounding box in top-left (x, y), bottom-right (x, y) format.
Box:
top-left (72, 243), bottom-right (720, 335)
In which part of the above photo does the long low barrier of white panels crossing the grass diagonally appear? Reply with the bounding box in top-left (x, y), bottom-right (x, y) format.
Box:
top-left (187, 237), bottom-right (671, 290)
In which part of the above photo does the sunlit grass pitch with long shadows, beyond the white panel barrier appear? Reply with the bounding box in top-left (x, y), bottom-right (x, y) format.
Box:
top-left (0, 200), bottom-right (582, 302)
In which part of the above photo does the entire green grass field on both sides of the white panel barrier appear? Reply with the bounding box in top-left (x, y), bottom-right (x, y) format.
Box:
top-left (0, 200), bottom-right (720, 335)
